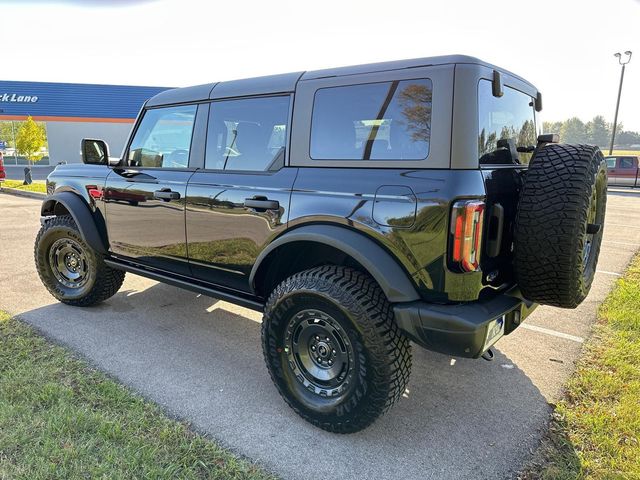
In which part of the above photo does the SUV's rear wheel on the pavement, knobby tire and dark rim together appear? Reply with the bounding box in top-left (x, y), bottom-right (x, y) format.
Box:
top-left (262, 266), bottom-right (411, 433)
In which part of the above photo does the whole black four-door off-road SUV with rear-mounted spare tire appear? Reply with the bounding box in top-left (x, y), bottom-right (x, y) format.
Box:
top-left (35, 56), bottom-right (607, 433)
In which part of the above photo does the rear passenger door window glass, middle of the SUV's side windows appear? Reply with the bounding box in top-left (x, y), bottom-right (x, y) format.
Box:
top-left (205, 97), bottom-right (289, 171)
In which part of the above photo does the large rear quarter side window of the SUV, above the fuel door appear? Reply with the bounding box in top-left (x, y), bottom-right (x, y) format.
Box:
top-left (310, 79), bottom-right (432, 160)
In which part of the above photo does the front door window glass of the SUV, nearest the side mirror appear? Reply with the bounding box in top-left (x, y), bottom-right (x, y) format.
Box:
top-left (127, 105), bottom-right (197, 168)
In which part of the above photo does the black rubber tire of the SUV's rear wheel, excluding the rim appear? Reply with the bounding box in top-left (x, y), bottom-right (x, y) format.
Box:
top-left (262, 265), bottom-right (411, 433)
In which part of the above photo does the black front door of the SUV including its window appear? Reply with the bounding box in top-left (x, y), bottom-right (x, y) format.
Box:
top-left (104, 105), bottom-right (197, 275)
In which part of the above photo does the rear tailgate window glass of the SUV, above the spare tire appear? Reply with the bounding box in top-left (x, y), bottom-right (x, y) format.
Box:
top-left (478, 80), bottom-right (537, 164)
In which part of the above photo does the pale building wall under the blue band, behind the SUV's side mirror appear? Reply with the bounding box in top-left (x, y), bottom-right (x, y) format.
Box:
top-left (46, 122), bottom-right (133, 165)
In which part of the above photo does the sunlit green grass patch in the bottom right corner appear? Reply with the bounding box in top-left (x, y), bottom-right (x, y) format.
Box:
top-left (522, 255), bottom-right (640, 479)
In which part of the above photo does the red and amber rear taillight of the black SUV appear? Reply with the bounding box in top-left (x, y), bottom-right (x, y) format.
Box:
top-left (451, 200), bottom-right (485, 272)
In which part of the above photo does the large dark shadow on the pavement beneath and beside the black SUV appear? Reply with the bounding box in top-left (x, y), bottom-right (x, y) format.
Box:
top-left (21, 284), bottom-right (568, 478)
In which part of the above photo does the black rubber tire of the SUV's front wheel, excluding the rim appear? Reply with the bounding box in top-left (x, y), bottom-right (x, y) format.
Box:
top-left (34, 215), bottom-right (125, 307)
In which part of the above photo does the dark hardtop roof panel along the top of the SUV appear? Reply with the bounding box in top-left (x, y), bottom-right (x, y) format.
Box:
top-left (146, 55), bottom-right (535, 107)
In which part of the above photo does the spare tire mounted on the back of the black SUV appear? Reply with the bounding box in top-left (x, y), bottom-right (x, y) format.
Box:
top-left (514, 144), bottom-right (607, 308)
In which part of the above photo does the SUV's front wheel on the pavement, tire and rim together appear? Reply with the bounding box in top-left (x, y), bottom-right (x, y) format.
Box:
top-left (34, 215), bottom-right (125, 307)
